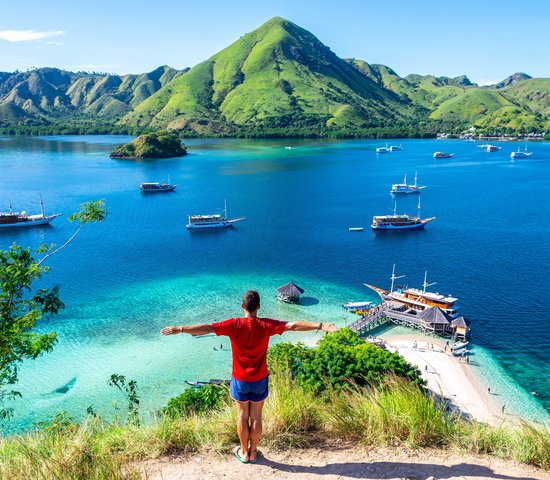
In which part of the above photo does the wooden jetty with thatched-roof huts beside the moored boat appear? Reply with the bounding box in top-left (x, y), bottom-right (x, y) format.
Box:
top-left (349, 301), bottom-right (469, 340)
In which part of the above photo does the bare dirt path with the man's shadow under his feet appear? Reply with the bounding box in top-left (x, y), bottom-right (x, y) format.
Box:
top-left (136, 447), bottom-right (550, 480)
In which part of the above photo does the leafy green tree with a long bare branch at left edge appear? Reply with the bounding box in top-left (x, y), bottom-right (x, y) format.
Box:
top-left (0, 200), bottom-right (107, 419)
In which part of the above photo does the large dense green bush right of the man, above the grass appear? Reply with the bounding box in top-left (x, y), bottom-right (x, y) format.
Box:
top-left (268, 328), bottom-right (423, 394)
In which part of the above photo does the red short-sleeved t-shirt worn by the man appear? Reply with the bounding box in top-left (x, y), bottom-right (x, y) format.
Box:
top-left (212, 318), bottom-right (286, 382)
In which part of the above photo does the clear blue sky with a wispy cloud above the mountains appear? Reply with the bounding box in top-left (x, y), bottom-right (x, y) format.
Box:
top-left (0, 0), bottom-right (550, 84)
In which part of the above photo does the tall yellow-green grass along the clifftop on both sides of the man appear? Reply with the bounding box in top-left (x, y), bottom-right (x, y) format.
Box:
top-left (0, 371), bottom-right (550, 480)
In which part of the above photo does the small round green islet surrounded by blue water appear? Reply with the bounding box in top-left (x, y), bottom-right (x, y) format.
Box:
top-left (109, 130), bottom-right (187, 159)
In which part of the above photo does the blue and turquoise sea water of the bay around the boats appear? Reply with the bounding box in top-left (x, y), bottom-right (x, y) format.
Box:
top-left (0, 136), bottom-right (550, 429)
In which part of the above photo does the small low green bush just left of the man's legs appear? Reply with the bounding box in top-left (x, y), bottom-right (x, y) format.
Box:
top-left (162, 385), bottom-right (229, 416)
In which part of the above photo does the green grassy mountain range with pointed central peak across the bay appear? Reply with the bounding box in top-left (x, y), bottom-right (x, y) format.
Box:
top-left (0, 17), bottom-right (550, 136)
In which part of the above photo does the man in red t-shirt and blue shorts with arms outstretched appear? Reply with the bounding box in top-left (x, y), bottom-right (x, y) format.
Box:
top-left (160, 290), bottom-right (338, 463)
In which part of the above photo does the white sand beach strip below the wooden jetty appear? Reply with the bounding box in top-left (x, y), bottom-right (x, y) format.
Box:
top-left (384, 336), bottom-right (505, 425)
